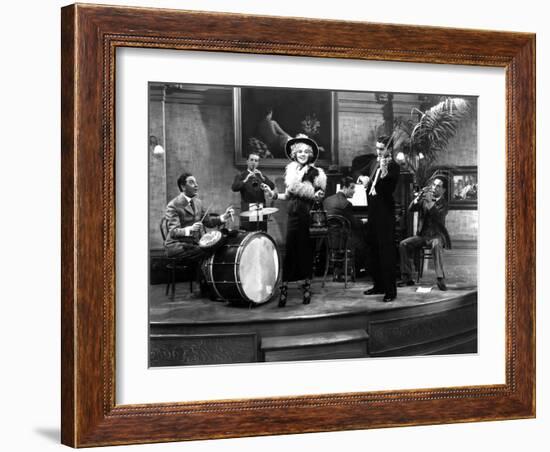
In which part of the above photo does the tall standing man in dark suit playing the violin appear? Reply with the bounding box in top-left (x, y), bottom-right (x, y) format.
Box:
top-left (359, 136), bottom-right (399, 302)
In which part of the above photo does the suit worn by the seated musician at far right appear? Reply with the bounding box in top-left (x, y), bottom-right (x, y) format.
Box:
top-left (399, 196), bottom-right (451, 280)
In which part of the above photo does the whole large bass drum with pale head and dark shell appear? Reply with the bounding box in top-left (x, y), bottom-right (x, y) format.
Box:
top-left (203, 231), bottom-right (281, 304)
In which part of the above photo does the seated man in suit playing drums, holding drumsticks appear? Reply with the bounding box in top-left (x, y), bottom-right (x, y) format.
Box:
top-left (164, 173), bottom-right (233, 261)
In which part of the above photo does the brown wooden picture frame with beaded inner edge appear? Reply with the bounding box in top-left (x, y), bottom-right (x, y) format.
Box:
top-left (61, 5), bottom-right (535, 447)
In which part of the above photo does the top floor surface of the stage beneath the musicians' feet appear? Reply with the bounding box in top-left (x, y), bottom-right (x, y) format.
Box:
top-left (149, 278), bottom-right (477, 324)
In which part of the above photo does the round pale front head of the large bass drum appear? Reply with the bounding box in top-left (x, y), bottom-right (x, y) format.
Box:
top-left (239, 233), bottom-right (279, 303)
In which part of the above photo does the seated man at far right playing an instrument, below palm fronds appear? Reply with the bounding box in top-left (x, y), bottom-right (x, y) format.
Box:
top-left (399, 176), bottom-right (451, 290)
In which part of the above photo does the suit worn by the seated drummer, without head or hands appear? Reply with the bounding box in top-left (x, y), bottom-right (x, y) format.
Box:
top-left (164, 193), bottom-right (221, 260)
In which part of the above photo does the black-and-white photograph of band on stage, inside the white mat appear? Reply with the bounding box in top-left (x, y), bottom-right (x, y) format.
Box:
top-left (148, 81), bottom-right (480, 367)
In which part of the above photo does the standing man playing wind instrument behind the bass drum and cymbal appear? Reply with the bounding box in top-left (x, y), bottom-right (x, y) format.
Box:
top-left (231, 153), bottom-right (275, 232)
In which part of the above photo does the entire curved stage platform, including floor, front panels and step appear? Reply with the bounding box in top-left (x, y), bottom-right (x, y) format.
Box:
top-left (149, 280), bottom-right (477, 366)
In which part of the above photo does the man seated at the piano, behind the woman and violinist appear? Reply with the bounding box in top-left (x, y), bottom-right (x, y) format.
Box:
top-left (323, 176), bottom-right (366, 274)
